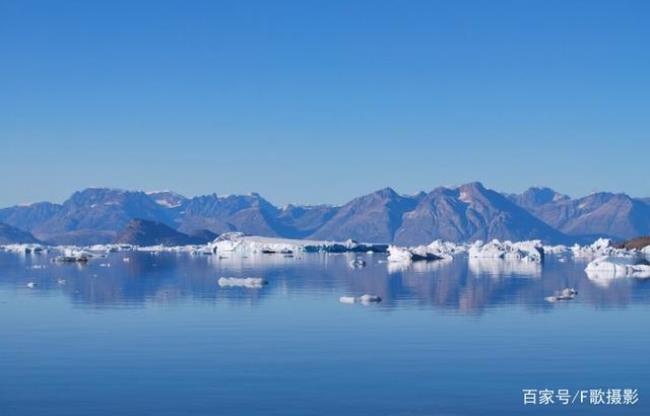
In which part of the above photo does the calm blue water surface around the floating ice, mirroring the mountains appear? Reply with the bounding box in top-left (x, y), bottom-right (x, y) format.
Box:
top-left (0, 253), bottom-right (650, 416)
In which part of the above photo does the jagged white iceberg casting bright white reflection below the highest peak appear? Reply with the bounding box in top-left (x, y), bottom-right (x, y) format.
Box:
top-left (468, 240), bottom-right (544, 263)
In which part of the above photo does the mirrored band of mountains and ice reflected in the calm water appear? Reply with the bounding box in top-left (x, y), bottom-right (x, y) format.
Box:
top-left (0, 253), bottom-right (650, 313)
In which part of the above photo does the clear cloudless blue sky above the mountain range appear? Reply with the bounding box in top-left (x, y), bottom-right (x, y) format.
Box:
top-left (0, 0), bottom-right (650, 206)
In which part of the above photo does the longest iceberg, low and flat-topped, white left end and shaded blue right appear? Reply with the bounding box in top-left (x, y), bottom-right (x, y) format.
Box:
top-left (208, 232), bottom-right (387, 255)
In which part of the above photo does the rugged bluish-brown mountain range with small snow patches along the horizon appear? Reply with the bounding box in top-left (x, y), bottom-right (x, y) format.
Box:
top-left (0, 182), bottom-right (650, 245)
